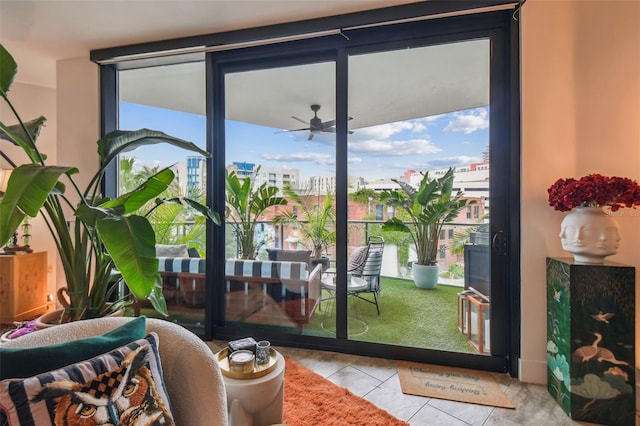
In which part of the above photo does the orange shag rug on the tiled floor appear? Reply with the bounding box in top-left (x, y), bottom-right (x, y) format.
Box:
top-left (283, 356), bottom-right (408, 426)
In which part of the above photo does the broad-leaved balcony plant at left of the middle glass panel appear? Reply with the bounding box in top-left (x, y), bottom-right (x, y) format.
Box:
top-left (225, 166), bottom-right (287, 259)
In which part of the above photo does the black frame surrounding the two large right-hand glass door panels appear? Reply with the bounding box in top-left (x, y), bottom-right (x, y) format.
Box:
top-left (207, 12), bottom-right (518, 374)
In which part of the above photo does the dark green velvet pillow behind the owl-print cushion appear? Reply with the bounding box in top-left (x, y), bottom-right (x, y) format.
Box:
top-left (0, 316), bottom-right (147, 380)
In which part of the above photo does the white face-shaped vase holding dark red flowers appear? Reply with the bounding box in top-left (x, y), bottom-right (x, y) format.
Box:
top-left (560, 208), bottom-right (620, 263)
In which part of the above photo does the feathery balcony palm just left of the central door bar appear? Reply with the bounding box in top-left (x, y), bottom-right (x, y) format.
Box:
top-left (274, 186), bottom-right (336, 270)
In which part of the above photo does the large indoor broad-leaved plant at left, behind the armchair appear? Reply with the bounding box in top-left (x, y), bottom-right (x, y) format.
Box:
top-left (0, 44), bottom-right (220, 322)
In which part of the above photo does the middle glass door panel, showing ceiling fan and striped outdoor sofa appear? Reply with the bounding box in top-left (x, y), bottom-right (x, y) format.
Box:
top-left (223, 57), bottom-right (336, 335)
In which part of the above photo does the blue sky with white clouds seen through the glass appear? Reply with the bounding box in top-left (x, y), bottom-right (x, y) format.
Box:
top-left (120, 102), bottom-right (489, 180)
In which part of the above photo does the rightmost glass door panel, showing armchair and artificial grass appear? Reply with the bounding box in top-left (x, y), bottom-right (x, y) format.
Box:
top-left (347, 38), bottom-right (491, 354)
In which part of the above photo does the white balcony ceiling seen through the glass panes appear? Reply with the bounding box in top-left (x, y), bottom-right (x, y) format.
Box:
top-left (119, 40), bottom-right (489, 130)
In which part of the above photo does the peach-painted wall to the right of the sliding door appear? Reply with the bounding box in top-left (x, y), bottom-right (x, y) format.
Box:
top-left (521, 0), bottom-right (640, 383)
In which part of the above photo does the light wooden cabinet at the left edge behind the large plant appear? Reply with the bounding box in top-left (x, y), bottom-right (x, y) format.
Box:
top-left (0, 252), bottom-right (47, 324)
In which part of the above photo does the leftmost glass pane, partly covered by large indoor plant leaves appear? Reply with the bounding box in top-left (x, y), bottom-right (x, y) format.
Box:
top-left (118, 62), bottom-right (207, 332)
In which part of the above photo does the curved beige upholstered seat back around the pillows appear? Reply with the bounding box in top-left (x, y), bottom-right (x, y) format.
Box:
top-left (2, 318), bottom-right (228, 426)
